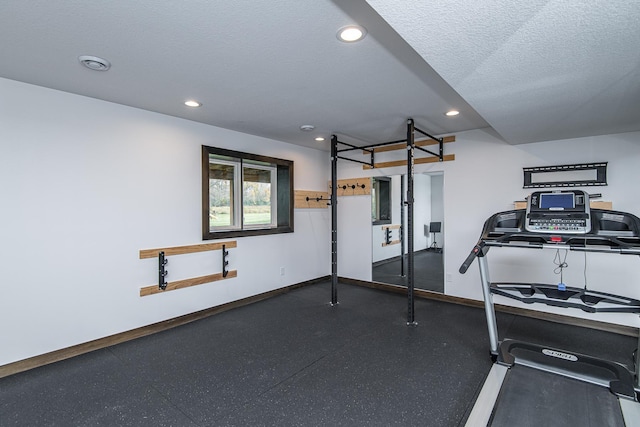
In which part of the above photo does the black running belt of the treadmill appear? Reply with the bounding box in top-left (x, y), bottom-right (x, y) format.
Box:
top-left (489, 365), bottom-right (625, 427)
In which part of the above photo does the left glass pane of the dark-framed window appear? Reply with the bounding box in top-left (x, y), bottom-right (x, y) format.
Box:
top-left (209, 163), bottom-right (236, 229)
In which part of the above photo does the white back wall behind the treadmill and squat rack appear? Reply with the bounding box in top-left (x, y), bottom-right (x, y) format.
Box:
top-left (338, 130), bottom-right (640, 326)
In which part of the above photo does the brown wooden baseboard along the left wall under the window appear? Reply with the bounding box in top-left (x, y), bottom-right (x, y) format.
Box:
top-left (0, 276), bottom-right (330, 378)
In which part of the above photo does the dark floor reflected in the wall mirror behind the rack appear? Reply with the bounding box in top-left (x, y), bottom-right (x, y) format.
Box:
top-left (372, 250), bottom-right (444, 293)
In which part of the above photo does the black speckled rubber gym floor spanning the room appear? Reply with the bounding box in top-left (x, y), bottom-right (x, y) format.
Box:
top-left (0, 282), bottom-right (636, 427)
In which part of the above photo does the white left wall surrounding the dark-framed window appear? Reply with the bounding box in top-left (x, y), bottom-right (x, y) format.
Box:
top-left (0, 79), bottom-right (330, 365)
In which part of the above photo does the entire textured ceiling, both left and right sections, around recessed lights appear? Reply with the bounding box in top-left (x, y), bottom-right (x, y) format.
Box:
top-left (0, 0), bottom-right (640, 149)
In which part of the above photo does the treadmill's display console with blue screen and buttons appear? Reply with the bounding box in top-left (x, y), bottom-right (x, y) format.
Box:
top-left (525, 190), bottom-right (591, 234)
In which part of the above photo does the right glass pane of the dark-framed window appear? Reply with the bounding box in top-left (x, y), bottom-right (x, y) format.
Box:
top-left (242, 167), bottom-right (274, 226)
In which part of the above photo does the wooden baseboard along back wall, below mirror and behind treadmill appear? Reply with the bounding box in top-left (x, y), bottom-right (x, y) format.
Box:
top-left (339, 277), bottom-right (639, 337)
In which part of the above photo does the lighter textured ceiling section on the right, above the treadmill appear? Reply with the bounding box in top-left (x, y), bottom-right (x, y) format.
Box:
top-left (368, 0), bottom-right (640, 144)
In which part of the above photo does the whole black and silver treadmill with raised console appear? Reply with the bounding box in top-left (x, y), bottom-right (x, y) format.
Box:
top-left (459, 190), bottom-right (640, 427)
